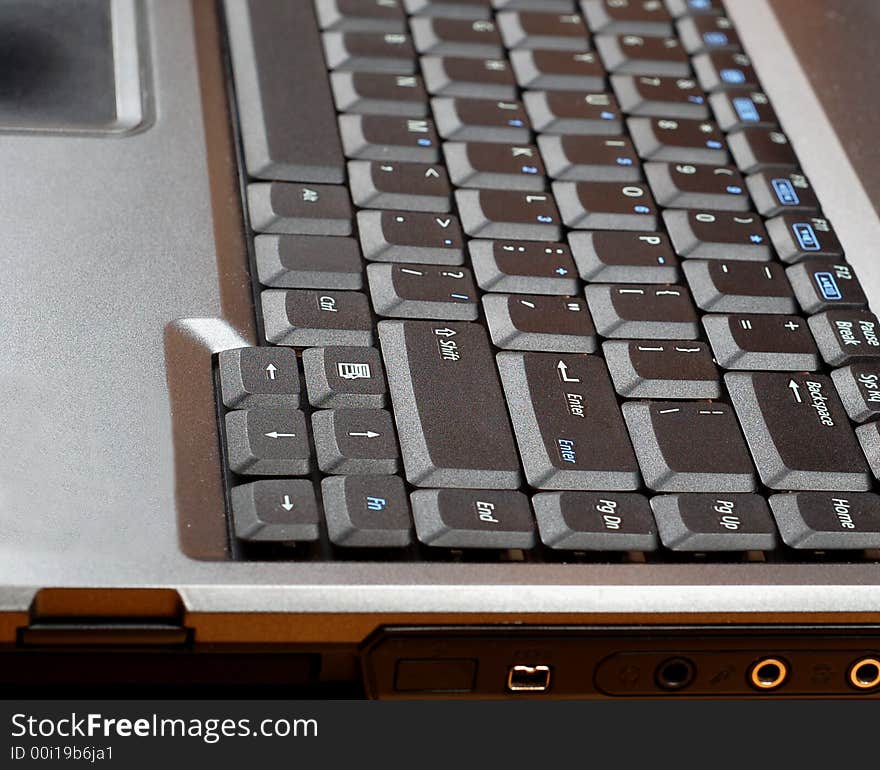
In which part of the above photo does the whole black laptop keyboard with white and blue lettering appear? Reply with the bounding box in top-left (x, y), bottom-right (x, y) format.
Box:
top-left (211, 0), bottom-right (880, 562)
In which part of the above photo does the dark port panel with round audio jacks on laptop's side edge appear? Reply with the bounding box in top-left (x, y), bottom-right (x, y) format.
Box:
top-left (362, 625), bottom-right (880, 698)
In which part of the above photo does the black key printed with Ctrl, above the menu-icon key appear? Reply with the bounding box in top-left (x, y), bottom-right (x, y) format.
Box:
top-left (260, 289), bottom-right (373, 347)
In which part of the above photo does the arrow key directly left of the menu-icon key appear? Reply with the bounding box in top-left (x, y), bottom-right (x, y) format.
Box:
top-left (217, 348), bottom-right (300, 409)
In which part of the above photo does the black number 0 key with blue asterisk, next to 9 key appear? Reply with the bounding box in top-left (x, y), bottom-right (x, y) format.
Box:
top-left (663, 211), bottom-right (773, 262)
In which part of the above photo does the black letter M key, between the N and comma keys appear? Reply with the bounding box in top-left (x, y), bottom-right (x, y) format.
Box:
top-left (339, 115), bottom-right (440, 163)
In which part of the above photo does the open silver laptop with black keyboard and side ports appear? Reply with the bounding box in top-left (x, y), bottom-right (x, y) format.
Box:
top-left (0, 0), bottom-right (880, 699)
